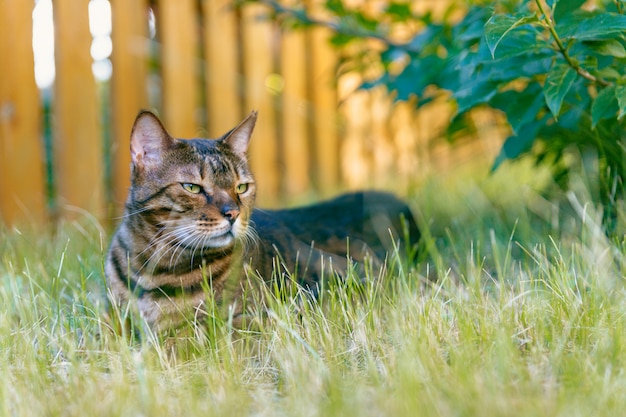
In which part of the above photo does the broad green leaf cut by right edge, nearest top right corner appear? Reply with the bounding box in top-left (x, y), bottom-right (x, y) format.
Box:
top-left (556, 13), bottom-right (626, 41)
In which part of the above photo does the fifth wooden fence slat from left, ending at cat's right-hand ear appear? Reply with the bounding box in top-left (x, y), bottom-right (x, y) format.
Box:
top-left (202, 0), bottom-right (244, 137)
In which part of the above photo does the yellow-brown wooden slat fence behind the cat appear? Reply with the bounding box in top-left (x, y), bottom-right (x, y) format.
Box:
top-left (0, 0), bottom-right (499, 224)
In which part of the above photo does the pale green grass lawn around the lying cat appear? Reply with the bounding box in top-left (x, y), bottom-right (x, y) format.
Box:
top-left (0, 158), bottom-right (626, 416)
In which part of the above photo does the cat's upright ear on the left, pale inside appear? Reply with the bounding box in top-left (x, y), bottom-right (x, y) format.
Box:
top-left (130, 110), bottom-right (175, 168)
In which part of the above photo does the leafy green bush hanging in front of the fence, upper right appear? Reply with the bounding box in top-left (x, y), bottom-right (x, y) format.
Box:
top-left (251, 0), bottom-right (626, 228)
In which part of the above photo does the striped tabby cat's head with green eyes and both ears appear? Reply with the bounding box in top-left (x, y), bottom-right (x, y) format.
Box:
top-left (127, 111), bottom-right (257, 251)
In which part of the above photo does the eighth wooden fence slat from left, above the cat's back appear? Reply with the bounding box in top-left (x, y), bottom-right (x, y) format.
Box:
top-left (310, 24), bottom-right (340, 195)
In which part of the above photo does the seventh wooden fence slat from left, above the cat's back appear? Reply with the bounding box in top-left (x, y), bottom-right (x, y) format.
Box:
top-left (280, 27), bottom-right (310, 197)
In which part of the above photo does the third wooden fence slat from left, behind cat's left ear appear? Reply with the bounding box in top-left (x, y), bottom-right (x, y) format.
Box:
top-left (111, 0), bottom-right (148, 207)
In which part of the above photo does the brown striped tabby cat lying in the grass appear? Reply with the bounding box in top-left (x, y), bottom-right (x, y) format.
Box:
top-left (105, 111), bottom-right (419, 332)
